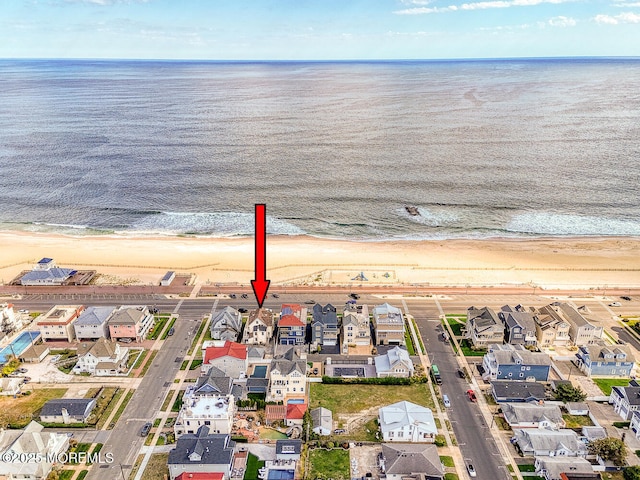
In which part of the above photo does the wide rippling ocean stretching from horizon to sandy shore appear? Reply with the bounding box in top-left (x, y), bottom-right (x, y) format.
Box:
top-left (0, 58), bottom-right (640, 241)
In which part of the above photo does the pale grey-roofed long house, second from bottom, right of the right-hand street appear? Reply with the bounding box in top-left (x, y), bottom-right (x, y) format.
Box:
top-left (512, 428), bottom-right (587, 457)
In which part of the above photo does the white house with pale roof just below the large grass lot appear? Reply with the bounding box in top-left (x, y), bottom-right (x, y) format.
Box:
top-left (378, 401), bottom-right (438, 443)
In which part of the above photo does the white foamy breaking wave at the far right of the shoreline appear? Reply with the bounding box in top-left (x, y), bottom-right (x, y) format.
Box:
top-left (506, 212), bottom-right (640, 236)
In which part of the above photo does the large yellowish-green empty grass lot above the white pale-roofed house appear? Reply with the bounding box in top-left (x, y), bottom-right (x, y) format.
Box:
top-left (309, 383), bottom-right (435, 415)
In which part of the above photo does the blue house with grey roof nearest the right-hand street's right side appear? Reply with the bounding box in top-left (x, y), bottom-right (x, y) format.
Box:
top-left (482, 344), bottom-right (551, 382)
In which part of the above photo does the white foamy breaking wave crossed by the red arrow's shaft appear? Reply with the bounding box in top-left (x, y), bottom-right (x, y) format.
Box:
top-left (127, 212), bottom-right (306, 237)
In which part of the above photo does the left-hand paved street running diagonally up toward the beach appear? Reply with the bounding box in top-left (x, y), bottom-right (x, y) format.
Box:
top-left (87, 301), bottom-right (208, 480)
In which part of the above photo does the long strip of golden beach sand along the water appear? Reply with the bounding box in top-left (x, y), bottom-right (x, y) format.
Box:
top-left (0, 232), bottom-right (640, 289)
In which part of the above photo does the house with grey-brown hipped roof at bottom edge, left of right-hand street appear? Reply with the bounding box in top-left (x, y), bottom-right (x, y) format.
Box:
top-left (380, 443), bottom-right (444, 480)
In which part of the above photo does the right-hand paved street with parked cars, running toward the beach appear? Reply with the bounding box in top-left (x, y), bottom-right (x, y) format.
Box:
top-left (406, 300), bottom-right (511, 480)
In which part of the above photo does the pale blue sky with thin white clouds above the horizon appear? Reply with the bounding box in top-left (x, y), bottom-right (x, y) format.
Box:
top-left (0, 0), bottom-right (640, 60)
